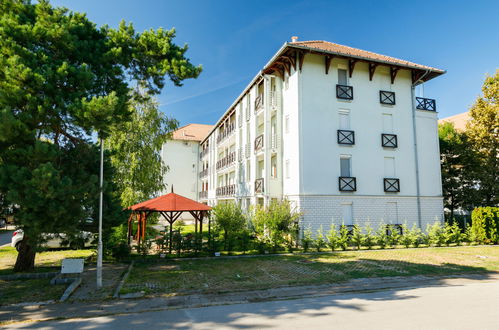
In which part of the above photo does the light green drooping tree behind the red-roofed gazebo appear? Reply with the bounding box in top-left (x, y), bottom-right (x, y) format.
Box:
top-left (106, 90), bottom-right (177, 208)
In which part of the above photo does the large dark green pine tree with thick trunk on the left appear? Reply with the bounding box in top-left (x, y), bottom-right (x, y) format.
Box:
top-left (0, 0), bottom-right (201, 270)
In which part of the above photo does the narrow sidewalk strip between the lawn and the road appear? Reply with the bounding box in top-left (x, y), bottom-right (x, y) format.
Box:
top-left (0, 273), bottom-right (499, 325)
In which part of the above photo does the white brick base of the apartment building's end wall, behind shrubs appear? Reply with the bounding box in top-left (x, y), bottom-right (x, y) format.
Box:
top-left (289, 195), bottom-right (443, 234)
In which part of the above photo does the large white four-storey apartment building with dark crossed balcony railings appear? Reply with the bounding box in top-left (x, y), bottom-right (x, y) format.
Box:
top-left (198, 37), bottom-right (445, 232)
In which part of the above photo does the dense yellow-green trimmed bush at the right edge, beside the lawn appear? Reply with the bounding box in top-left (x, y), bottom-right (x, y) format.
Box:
top-left (471, 206), bottom-right (499, 244)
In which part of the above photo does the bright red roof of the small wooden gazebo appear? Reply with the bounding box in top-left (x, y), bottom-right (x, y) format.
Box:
top-left (128, 193), bottom-right (211, 212)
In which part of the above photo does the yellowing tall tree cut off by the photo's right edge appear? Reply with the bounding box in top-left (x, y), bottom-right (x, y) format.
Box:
top-left (466, 70), bottom-right (499, 206)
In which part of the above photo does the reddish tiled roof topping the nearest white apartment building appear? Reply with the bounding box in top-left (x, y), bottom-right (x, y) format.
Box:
top-left (288, 40), bottom-right (445, 73)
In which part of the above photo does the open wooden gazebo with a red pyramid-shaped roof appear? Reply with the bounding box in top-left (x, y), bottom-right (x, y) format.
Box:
top-left (128, 189), bottom-right (211, 253)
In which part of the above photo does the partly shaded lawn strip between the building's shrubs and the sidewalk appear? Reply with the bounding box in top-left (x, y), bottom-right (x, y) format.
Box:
top-left (122, 246), bottom-right (499, 295)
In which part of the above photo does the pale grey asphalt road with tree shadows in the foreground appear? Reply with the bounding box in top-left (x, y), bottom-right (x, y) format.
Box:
top-left (9, 280), bottom-right (499, 330)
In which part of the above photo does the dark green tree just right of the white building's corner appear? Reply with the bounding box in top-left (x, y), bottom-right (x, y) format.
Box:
top-left (438, 123), bottom-right (477, 221)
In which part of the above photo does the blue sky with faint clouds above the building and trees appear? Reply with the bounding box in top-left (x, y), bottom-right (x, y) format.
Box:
top-left (51, 0), bottom-right (499, 125)
